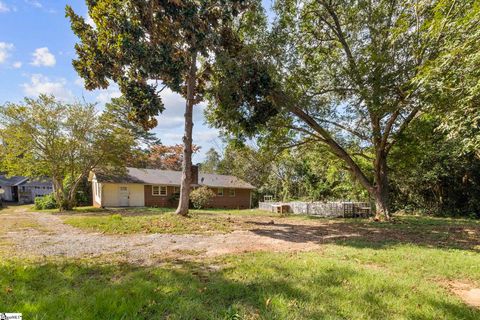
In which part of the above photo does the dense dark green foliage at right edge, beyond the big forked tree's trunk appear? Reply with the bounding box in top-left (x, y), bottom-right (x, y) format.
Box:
top-left (390, 114), bottom-right (480, 218)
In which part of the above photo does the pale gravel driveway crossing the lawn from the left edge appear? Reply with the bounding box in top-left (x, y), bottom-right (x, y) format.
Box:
top-left (0, 207), bottom-right (352, 265)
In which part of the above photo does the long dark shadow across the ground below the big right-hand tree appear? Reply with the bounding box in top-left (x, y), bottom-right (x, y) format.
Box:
top-left (248, 217), bottom-right (480, 252)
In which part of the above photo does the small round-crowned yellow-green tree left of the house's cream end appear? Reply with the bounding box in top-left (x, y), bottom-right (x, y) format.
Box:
top-left (0, 95), bottom-right (135, 210)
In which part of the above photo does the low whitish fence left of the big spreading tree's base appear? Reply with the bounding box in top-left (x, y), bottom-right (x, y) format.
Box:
top-left (258, 202), bottom-right (370, 218)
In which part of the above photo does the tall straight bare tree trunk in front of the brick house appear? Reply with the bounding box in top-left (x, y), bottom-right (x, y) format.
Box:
top-left (176, 53), bottom-right (197, 216)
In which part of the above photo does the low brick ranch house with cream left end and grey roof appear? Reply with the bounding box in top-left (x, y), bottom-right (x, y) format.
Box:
top-left (89, 166), bottom-right (255, 209)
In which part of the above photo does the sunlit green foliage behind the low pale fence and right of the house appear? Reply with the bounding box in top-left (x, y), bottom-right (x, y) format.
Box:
top-left (208, 140), bottom-right (371, 205)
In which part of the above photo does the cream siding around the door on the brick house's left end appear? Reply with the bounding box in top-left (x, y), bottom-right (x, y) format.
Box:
top-left (101, 183), bottom-right (145, 207)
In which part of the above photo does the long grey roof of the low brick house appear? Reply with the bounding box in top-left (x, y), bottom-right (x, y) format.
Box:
top-left (95, 168), bottom-right (255, 189)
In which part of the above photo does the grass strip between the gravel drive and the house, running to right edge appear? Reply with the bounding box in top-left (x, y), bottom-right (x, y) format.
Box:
top-left (61, 208), bottom-right (480, 241)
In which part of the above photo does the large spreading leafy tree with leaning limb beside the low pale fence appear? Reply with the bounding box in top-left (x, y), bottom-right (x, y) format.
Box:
top-left (209, 0), bottom-right (470, 219)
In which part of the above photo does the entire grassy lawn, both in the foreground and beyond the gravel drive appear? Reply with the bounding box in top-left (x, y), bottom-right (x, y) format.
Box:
top-left (0, 206), bottom-right (480, 320)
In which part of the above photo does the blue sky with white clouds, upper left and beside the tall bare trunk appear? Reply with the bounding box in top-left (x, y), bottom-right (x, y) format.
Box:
top-left (0, 0), bottom-right (271, 162)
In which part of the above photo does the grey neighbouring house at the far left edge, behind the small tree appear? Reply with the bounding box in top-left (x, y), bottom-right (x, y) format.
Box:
top-left (0, 174), bottom-right (53, 203)
